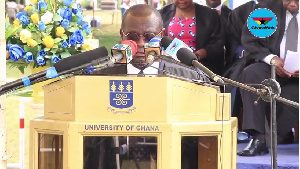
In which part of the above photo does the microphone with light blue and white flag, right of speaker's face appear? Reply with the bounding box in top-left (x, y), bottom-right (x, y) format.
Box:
top-left (161, 36), bottom-right (193, 60)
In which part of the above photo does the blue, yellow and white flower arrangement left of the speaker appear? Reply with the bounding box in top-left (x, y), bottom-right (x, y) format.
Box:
top-left (5, 0), bottom-right (94, 73)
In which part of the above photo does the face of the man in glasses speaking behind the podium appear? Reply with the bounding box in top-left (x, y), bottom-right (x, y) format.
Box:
top-left (120, 14), bottom-right (165, 69)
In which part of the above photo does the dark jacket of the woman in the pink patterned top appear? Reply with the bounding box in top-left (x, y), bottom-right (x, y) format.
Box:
top-left (160, 4), bottom-right (224, 74)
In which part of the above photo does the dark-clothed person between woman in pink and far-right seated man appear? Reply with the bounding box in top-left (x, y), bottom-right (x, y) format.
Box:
top-left (223, 0), bottom-right (266, 132)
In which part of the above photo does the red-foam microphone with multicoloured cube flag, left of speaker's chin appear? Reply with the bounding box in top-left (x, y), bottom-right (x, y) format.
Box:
top-left (111, 40), bottom-right (137, 64)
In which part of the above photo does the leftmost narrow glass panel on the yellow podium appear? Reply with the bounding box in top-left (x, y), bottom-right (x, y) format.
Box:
top-left (38, 133), bottom-right (64, 169)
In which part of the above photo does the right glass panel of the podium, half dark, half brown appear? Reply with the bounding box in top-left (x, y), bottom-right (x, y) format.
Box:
top-left (181, 136), bottom-right (218, 169)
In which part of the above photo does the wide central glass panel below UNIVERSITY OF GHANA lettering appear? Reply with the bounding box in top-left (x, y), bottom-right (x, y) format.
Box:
top-left (83, 136), bottom-right (157, 169)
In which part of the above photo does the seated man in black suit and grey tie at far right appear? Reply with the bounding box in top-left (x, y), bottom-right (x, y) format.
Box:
top-left (238, 0), bottom-right (299, 156)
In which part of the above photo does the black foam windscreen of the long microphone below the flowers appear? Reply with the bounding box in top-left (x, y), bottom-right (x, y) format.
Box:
top-left (53, 46), bottom-right (108, 73)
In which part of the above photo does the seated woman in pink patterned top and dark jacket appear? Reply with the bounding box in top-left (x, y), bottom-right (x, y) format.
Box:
top-left (160, 0), bottom-right (224, 74)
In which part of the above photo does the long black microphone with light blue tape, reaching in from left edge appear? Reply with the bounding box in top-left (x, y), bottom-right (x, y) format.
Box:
top-left (0, 47), bottom-right (108, 95)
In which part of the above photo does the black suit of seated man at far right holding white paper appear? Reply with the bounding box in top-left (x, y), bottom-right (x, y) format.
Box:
top-left (241, 0), bottom-right (299, 138)
